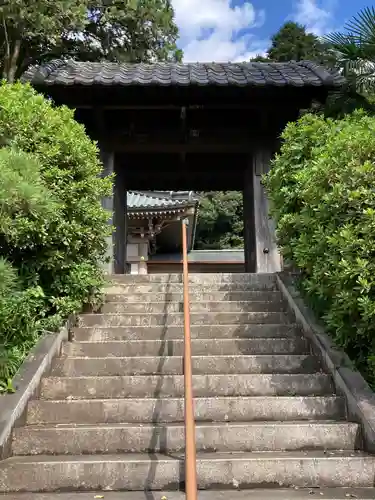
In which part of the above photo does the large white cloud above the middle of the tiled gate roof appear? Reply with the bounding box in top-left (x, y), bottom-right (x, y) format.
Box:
top-left (172, 0), bottom-right (267, 62)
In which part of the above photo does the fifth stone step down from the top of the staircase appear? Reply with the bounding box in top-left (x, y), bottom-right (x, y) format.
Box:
top-left (78, 312), bottom-right (289, 327)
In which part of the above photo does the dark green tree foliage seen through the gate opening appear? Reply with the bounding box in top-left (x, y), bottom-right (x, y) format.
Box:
top-left (195, 191), bottom-right (243, 250)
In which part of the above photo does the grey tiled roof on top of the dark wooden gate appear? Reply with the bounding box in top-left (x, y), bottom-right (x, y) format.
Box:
top-left (22, 60), bottom-right (344, 87)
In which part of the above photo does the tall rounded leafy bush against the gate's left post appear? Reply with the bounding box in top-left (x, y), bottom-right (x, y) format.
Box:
top-left (0, 84), bottom-right (111, 310)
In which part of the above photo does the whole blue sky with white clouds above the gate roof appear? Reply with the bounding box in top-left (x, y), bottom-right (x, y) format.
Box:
top-left (172, 0), bottom-right (375, 62)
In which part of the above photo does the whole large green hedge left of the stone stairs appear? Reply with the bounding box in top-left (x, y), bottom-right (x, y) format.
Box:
top-left (0, 83), bottom-right (112, 390)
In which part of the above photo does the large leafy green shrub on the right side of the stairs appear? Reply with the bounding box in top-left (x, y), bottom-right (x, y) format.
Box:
top-left (265, 112), bottom-right (375, 384)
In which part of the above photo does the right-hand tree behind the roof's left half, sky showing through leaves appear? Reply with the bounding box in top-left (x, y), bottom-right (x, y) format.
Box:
top-left (70, 0), bottom-right (182, 62)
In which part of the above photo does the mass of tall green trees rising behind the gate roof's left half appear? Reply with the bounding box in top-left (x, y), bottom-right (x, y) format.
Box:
top-left (0, 0), bottom-right (181, 82)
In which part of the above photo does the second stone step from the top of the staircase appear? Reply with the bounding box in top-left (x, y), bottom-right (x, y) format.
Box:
top-left (105, 282), bottom-right (278, 295)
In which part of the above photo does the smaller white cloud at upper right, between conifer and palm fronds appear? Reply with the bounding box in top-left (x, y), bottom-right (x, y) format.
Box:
top-left (293, 0), bottom-right (336, 36)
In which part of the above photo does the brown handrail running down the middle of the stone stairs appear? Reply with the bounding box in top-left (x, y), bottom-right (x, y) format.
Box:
top-left (182, 219), bottom-right (197, 500)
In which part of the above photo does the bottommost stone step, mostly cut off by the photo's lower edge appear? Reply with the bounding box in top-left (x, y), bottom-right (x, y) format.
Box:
top-left (2, 487), bottom-right (375, 500)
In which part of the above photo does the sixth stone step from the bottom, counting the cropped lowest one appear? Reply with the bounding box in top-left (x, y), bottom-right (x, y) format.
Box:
top-left (51, 354), bottom-right (319, 377)
